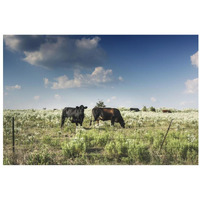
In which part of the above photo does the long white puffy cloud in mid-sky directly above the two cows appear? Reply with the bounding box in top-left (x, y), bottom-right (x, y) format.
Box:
top-left (51, 67), bottom-right (113, 89)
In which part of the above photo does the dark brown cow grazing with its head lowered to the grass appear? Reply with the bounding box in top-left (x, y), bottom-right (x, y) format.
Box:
top-left (90, 107), bottom-right (125, 128)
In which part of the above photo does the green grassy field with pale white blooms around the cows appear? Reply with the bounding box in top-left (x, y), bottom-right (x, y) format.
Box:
top-left (3, 108), bottom-right (198, 165)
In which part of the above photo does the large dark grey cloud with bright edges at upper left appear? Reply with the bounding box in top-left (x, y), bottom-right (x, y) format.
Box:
top-left (4, 36), bottom-right (105, 68)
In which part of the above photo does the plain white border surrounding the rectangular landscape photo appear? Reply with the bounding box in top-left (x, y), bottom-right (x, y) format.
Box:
top-left (0, 0), bottom-right (200, 200)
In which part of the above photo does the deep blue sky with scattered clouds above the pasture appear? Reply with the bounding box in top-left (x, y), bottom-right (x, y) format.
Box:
top-left (3, 35), bottom-right (198, 109)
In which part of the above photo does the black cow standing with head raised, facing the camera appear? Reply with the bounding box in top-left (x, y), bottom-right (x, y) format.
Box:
top-left (61, 105), bottom-right (87, 128)
